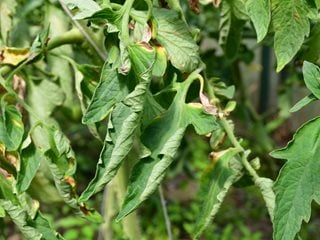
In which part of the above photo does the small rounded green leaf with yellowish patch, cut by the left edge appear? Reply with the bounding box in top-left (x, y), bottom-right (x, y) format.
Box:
top-left (0, 102), bottom-right (24, 151)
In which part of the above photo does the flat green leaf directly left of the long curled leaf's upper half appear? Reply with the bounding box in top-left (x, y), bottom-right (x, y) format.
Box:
top-left (82, 64), bottom-right (129, 124)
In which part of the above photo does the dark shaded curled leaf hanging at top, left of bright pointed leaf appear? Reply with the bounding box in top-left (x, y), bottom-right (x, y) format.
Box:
top-left (219, 1), bottom-right (245, 60)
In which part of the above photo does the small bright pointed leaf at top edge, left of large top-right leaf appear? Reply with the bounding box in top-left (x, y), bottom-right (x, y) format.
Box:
top-left (246, 0), bottom-right (271, 42)
